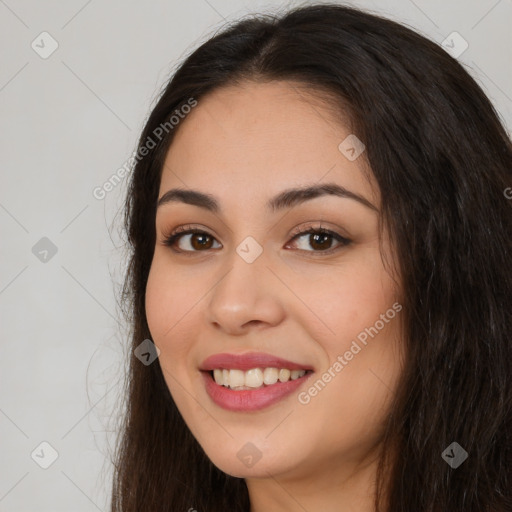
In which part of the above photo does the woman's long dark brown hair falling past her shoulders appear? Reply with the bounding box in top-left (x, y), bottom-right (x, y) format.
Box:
top-left (111, 4), bottom-right (512, 512)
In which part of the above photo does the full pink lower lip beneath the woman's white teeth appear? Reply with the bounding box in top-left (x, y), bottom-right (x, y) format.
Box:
top-left (201, 371), bottom-right (312, 412)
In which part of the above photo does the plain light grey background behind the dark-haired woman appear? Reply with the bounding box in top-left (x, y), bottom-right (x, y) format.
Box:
top-left (0, 0), bottom-right (512, 512)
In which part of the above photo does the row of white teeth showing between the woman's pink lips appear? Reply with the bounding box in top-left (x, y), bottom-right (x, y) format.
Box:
top-left (213, 368), bottom-right (306, 390)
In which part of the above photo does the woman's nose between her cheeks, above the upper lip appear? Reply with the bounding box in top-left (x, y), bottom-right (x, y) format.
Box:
top-left (207, 247), bottom-right (285, 335)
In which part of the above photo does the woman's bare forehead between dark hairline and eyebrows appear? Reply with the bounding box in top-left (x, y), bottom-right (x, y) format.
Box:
top-left (159, 81), bottom-right (378, 208)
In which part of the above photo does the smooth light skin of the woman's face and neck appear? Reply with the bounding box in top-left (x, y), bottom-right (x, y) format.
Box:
top-left (146, 81), bottom-right (402, 512)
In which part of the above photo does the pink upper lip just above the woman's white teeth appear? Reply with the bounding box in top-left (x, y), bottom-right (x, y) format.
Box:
top-left (200, 352), bottom-right (313, 371)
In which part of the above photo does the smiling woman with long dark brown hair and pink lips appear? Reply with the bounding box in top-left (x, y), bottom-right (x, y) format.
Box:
top-left (112, 4), bottom-right (512, 512)
